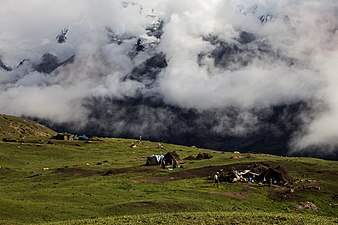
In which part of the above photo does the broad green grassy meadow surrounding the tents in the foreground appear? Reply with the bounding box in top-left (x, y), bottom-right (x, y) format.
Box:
top-left (0, 117), bottom-right (338, 224)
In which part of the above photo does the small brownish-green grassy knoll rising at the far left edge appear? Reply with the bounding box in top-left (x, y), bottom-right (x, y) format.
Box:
top-left (0, 115), bottom-right (55, 140)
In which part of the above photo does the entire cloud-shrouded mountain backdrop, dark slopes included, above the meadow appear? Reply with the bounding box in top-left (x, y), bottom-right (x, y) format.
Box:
top-left (0, 0), bottom-right (338, 157)
